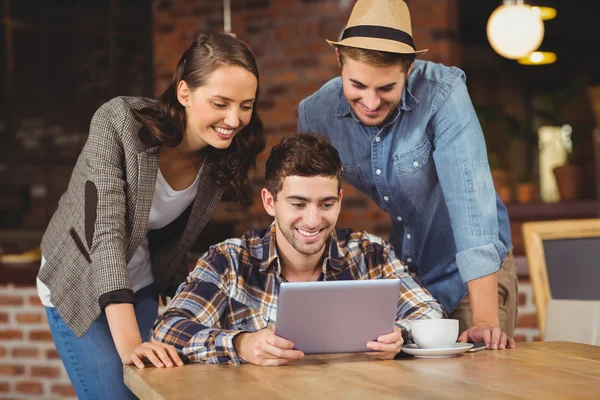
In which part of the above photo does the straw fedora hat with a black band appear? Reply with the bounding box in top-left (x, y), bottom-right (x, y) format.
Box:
top-left (327, 0), bottom-right (428, 56)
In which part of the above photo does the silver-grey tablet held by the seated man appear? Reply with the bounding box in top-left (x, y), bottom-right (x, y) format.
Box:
top-left (275, 279), bottom-right (400, 354)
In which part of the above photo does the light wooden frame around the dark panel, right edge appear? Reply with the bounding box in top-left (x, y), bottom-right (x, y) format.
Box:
top-left (522, 219), bottom-right (600, 338)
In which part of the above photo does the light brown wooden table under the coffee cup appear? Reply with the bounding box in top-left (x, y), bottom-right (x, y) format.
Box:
top-left (124, 342), bottom-right (600, 400)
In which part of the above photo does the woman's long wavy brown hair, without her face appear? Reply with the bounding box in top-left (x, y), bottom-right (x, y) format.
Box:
top-left (134, 34), bottom-right (265, 204)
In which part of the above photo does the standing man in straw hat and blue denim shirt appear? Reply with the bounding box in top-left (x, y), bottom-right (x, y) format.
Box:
top-left (298, 0), bottom-right (517, 349)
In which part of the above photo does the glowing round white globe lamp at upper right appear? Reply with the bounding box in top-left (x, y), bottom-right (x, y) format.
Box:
top-left (487, 4), bottom-right (544, 60)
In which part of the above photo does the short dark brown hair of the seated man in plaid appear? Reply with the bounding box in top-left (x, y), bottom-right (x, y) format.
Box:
top-left (265, 133), bottom-right (342, 199)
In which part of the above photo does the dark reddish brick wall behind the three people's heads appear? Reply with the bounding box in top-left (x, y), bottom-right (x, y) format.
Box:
top-left (154, 0), bottom-right (461, 237)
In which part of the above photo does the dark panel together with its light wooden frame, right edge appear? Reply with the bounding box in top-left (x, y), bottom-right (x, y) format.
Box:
top-left (523, 219), bottom-right (600, 337)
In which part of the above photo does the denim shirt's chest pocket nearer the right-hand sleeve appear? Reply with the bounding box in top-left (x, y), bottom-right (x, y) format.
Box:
top-left (394, 138), bottom-right (437, 209)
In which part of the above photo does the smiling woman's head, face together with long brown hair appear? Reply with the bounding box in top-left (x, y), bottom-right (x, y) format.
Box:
top-left (135, 34), bottom-right (265, 202)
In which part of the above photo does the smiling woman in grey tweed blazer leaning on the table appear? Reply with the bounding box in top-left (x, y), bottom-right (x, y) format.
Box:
top-left (37, 34), bottom-right (265, 399)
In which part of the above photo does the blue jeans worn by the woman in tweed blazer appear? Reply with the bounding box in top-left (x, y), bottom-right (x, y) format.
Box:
top-left (46, 284), bottom-right (158, 400)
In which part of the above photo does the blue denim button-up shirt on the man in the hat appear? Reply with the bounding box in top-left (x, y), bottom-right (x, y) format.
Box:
top-left (298, 60), bottom-right (512, 313)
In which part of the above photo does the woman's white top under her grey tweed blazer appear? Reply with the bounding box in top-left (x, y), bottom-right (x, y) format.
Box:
top-left (37, 168), bottom-right (202, 307)
